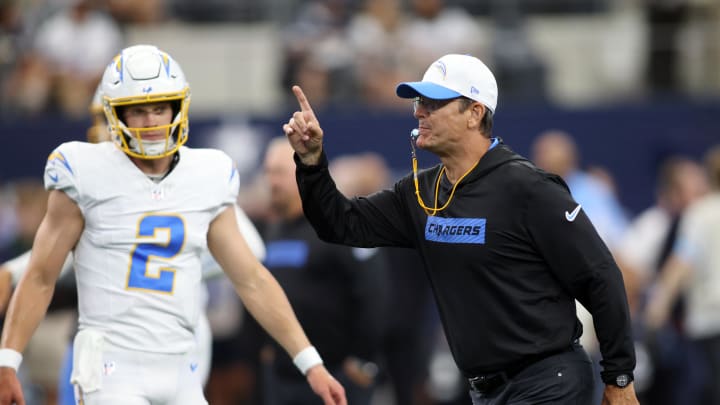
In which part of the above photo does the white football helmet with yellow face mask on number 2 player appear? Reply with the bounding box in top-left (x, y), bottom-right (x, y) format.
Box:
top-left (100, 45), bottom-right (190, 159)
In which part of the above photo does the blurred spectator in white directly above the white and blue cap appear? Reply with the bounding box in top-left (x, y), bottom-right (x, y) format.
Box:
top-left (394, 0), bottom-right (489, 79)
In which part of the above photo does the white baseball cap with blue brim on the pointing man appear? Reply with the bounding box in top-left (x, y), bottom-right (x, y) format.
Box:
top-left (395, 54), bottom-right (497, 113)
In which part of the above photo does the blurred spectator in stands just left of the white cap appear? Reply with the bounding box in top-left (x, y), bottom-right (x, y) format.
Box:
top-left (348, 0), bottom-right (407, 108)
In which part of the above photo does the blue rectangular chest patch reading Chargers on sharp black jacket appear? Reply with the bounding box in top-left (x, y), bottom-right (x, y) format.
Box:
top-left (425, 217), bottom-right (487, 244)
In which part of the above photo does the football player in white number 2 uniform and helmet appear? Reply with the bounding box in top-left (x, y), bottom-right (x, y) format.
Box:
top-left (0, 45), bottom-right (346, 405)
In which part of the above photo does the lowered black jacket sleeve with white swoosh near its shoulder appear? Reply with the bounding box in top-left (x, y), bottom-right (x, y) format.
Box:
top-left (525, 175), bottom-right (635, 382)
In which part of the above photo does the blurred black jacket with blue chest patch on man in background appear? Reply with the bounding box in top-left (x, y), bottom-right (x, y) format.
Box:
top-left (263, 216), bottom-right (386, 381)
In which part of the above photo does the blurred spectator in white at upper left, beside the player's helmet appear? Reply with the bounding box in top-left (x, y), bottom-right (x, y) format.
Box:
top-left (7, 0), bottom-right (123, 118)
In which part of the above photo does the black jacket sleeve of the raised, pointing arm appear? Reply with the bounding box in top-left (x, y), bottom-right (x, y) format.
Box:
top-left (295, 152), bottom-right (413, 247)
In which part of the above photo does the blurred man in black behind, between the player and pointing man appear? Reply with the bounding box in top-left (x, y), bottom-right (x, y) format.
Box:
top-left (256, 137), bottom-right (386, 405)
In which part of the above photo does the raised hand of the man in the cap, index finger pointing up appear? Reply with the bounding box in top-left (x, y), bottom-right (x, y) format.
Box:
top-left (283, 86), bottom-right (323, 166)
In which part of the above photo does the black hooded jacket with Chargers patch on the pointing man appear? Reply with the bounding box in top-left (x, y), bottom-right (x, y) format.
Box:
top-left (296, 143), bottom-right (635, 381)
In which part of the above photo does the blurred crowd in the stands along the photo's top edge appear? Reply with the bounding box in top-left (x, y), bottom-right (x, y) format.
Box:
top-left (0, 0), bottom-right (719, 119)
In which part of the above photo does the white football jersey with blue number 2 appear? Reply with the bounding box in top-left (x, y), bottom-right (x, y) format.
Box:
top-left (45, 142), bottom-right (239, 353)
